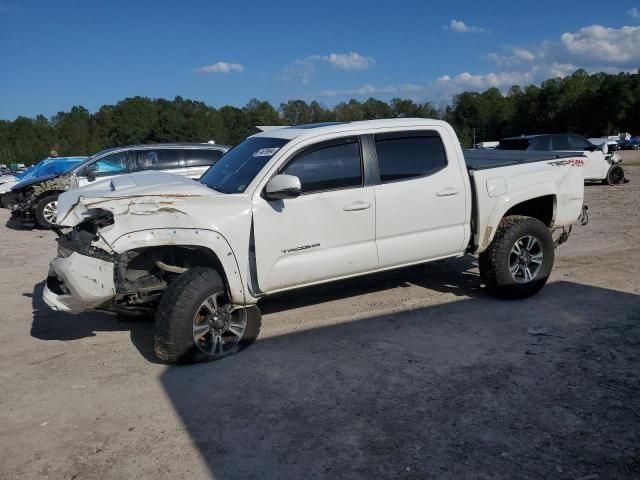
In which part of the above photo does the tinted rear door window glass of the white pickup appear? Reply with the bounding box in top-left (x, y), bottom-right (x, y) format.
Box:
top-left (375, 132), bottom-right (447, 183)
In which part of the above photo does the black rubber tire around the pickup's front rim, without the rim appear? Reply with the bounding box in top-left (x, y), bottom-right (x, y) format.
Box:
top-left (155, 267), bottom-right (262, 363)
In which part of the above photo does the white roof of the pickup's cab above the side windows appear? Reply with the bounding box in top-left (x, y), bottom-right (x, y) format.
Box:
top-left (253, 118), bottom-right (449, 140)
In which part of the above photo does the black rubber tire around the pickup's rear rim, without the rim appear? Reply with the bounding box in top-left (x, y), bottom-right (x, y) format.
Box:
top-left (479, 215), bottom-right (554, 299)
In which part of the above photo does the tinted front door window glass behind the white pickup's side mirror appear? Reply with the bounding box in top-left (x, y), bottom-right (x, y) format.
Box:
top-left (282, 138), bottom-right (362, 193)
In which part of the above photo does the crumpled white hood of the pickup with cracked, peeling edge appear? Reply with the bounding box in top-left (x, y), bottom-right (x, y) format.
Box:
top-left (58, 172), bottom-right (219, 227)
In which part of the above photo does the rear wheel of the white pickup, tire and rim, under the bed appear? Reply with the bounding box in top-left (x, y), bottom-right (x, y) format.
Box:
top-left (479, 215), bottom-right (554, 299)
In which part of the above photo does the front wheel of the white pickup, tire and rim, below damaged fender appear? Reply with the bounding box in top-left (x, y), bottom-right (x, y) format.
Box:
top-left (155, 267), bottom-right (261, 363)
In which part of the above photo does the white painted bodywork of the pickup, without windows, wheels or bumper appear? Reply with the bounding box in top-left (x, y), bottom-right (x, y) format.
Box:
top-left (46, 119), bottom-right (584, 305)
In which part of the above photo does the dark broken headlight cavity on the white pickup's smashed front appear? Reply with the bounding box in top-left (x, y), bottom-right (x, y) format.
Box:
top-left (55, 210), bottom-right (113, 260)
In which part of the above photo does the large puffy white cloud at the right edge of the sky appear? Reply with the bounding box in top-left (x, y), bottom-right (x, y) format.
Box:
top-left (560, 25), bottom-right (640, 67)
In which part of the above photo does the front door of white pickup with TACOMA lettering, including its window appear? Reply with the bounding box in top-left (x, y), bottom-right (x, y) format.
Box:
top-left (253, 136), bottom-right (378, 293)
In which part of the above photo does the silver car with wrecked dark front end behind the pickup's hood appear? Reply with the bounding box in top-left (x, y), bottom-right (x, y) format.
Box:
top-left (2, 143), bottom-right (229, 228)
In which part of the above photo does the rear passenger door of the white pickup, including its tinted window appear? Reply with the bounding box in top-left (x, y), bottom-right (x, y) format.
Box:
top-left (374, 128), bottom-right (467, 268)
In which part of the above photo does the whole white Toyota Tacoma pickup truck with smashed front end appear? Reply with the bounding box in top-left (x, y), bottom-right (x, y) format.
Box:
top-left (44, 119), bottom-right (584, 362)
